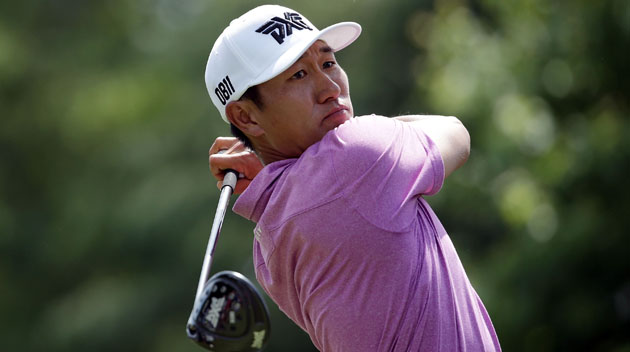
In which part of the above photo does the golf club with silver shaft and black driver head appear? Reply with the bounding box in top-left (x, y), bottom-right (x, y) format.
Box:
top-left (186, 170), bottom-right (271, 352)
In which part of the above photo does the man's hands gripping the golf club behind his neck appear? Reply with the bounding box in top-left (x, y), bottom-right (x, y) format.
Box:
top-left (208, 137), bottom-right (263, 194)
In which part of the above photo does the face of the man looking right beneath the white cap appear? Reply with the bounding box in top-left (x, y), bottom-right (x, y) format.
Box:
top-left (251, 41), bottom-right (354, 161)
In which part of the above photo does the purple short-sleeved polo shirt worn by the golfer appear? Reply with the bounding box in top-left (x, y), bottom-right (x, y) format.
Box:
top-left (234, 115), bottom-right (500, 352)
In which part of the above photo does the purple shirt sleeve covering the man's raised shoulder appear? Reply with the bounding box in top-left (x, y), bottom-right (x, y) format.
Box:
top-left (327, 115), bottom-right (444, 231)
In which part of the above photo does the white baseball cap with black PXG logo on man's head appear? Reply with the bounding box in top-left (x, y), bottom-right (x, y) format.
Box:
top-left (205, 5), bottom-right (361, 123)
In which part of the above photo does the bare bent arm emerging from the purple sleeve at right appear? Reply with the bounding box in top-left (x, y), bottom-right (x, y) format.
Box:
top-left (396, 115), bottom-right (470, 177)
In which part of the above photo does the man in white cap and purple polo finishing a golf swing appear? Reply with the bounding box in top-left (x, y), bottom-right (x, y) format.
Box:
top-left (206, 5), bottom-right (500, 352)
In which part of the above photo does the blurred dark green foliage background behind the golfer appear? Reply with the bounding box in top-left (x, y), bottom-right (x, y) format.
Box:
top-left (0, 0), bottom-right (630, 351)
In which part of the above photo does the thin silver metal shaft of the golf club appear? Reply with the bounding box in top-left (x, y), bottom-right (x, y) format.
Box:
top-left (195, 170), bottom-right (238, 302)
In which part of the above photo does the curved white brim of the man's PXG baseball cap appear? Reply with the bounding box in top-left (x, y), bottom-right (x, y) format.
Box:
top-left (250, 22), bottom-right (361, 86)
